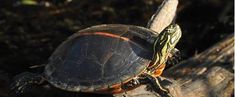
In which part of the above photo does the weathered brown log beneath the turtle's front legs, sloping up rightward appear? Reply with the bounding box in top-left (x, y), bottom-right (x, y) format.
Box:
top-left (116, 35), bottom-right (234, 97)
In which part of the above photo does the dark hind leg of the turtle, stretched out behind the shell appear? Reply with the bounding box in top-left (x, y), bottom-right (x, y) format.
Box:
top-left (10, 72), bottom-right (44, 95)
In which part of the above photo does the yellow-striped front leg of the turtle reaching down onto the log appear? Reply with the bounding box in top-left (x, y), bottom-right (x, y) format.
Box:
top-left (145, 74), bottom-right (172, 97)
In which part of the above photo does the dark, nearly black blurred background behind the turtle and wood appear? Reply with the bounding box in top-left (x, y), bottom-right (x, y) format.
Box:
top-left (0, 0), bottom-right (234, 96)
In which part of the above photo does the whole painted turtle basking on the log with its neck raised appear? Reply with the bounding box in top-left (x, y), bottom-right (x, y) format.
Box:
top-left (11, 24), bottom-right (181, 94)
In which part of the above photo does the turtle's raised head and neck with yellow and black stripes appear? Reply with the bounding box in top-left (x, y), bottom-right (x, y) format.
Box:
top-left (150, 24), bottom-right (182, 67)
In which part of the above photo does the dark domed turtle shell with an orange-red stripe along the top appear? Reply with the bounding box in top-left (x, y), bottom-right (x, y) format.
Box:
top-left (44, 24), bottom-right (157, 92)
